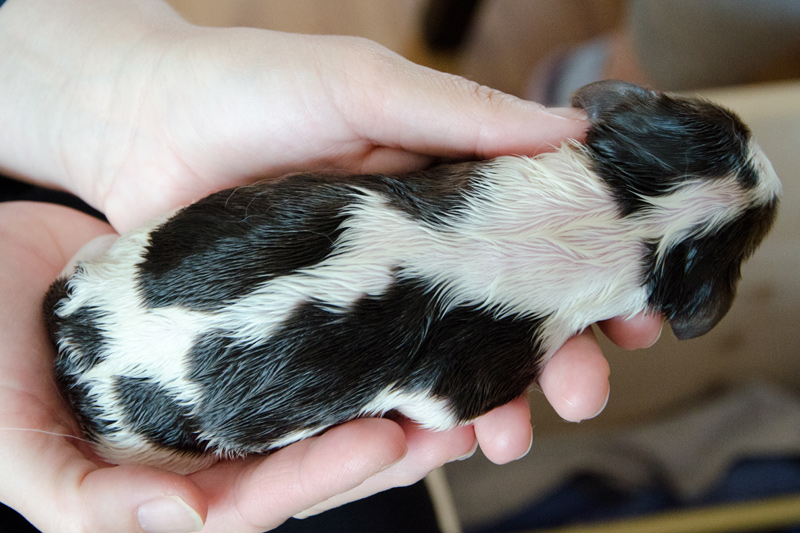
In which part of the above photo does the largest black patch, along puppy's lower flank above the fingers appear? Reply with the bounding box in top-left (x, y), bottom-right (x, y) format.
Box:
top-left (189, 281), bottom-right (540, 450)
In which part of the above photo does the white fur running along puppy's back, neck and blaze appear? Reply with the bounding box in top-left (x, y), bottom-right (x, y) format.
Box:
top-left (57, 139), bottom-right (780, 470)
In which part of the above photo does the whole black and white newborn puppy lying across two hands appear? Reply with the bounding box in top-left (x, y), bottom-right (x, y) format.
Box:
top-left (45, 82), bottom-right (781, 472)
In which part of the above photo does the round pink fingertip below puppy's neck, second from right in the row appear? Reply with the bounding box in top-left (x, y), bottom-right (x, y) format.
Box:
top-left (539, 328), bottom-right (610, 422)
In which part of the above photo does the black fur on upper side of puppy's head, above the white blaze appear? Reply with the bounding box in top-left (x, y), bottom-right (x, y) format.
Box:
top-left (586, 91), bottom-right (758, 215)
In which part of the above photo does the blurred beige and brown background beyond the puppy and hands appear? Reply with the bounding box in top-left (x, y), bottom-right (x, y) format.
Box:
top-left (170, 0), bottom-right (800, 532)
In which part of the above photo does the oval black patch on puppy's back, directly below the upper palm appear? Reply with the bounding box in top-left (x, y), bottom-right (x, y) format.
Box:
top-left (139, 176), bottom-right (350, 311)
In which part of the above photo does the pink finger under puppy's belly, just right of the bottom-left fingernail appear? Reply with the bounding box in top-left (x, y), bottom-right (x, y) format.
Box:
top-left (192, 419), bottom-right (406, 532)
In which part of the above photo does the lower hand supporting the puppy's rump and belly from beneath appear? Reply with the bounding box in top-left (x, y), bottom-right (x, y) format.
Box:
top-left (0, 203), bottom-right (660, 532)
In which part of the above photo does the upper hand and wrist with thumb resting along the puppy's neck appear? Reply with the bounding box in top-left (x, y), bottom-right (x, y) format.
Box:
top-left (0, 0), bottom-right (586, 231)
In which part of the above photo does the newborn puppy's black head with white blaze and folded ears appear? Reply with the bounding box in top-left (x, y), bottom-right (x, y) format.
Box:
top-left (572, 81), bottom-right (781, 339)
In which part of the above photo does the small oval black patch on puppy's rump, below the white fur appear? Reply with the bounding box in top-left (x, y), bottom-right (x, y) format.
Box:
top-left (114, 376), bottom-right (210, 454)
